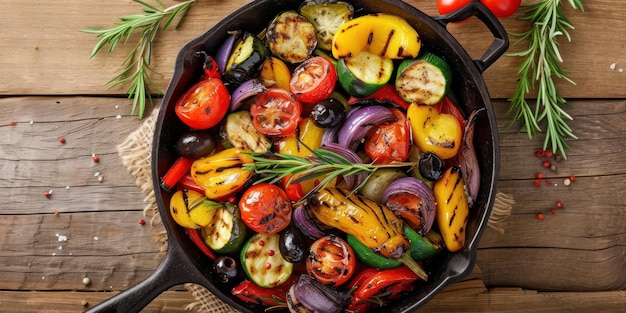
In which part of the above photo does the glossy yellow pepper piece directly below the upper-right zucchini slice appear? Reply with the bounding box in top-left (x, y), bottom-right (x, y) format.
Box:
top-left (406, 103), bottom-right (463, 160)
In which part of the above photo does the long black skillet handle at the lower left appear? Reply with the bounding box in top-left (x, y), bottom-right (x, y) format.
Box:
top-left (86, 248), bottom-right (192, 313)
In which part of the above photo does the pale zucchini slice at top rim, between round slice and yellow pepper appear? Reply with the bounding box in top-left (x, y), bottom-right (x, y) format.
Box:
top-left (300, 1), bottom-right (354, 51)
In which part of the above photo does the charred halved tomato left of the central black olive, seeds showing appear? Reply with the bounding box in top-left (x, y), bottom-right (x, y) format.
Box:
top-left (250, 88), bottom-right (302, 136)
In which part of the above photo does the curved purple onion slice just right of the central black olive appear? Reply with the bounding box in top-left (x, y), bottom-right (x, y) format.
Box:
top-left (338, 105), bottom-right (395, 151)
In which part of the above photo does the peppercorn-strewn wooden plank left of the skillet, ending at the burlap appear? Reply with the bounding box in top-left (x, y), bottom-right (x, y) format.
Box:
top-left (0, 97), bottom-right (145, 214)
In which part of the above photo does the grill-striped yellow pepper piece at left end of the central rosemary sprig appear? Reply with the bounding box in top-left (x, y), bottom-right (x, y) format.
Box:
top-left (191, 148), bottom-right (254, 199)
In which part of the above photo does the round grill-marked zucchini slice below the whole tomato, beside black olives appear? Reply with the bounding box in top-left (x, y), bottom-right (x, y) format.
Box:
top-left (240, 233), bottom-right (293, 288)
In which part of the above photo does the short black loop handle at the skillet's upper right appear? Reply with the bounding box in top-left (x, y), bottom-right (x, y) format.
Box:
top-left (434, 0), bottom-right (509, 73)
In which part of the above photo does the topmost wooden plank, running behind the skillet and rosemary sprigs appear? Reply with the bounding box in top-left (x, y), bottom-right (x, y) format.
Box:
top-left (0, 0), bottom-right (626, 99)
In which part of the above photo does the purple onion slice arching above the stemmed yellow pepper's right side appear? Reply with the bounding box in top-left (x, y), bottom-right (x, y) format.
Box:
top-left (382, 177), bottom-right (436, 235)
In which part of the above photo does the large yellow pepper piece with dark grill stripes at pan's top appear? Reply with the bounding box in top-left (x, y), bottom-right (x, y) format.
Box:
top-left (332, 14), bottom-right (421, 59)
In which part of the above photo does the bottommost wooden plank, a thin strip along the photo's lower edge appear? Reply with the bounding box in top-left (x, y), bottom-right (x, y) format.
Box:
top-left (0, 288), bottom-right (626, 313)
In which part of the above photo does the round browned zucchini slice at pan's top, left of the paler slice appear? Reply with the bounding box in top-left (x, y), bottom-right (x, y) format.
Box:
top-left (266, 11), bottom-right (317, 64)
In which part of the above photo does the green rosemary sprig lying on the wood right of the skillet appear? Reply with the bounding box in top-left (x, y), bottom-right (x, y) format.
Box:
top-left (508, 0), bottom-right (584, 158)
